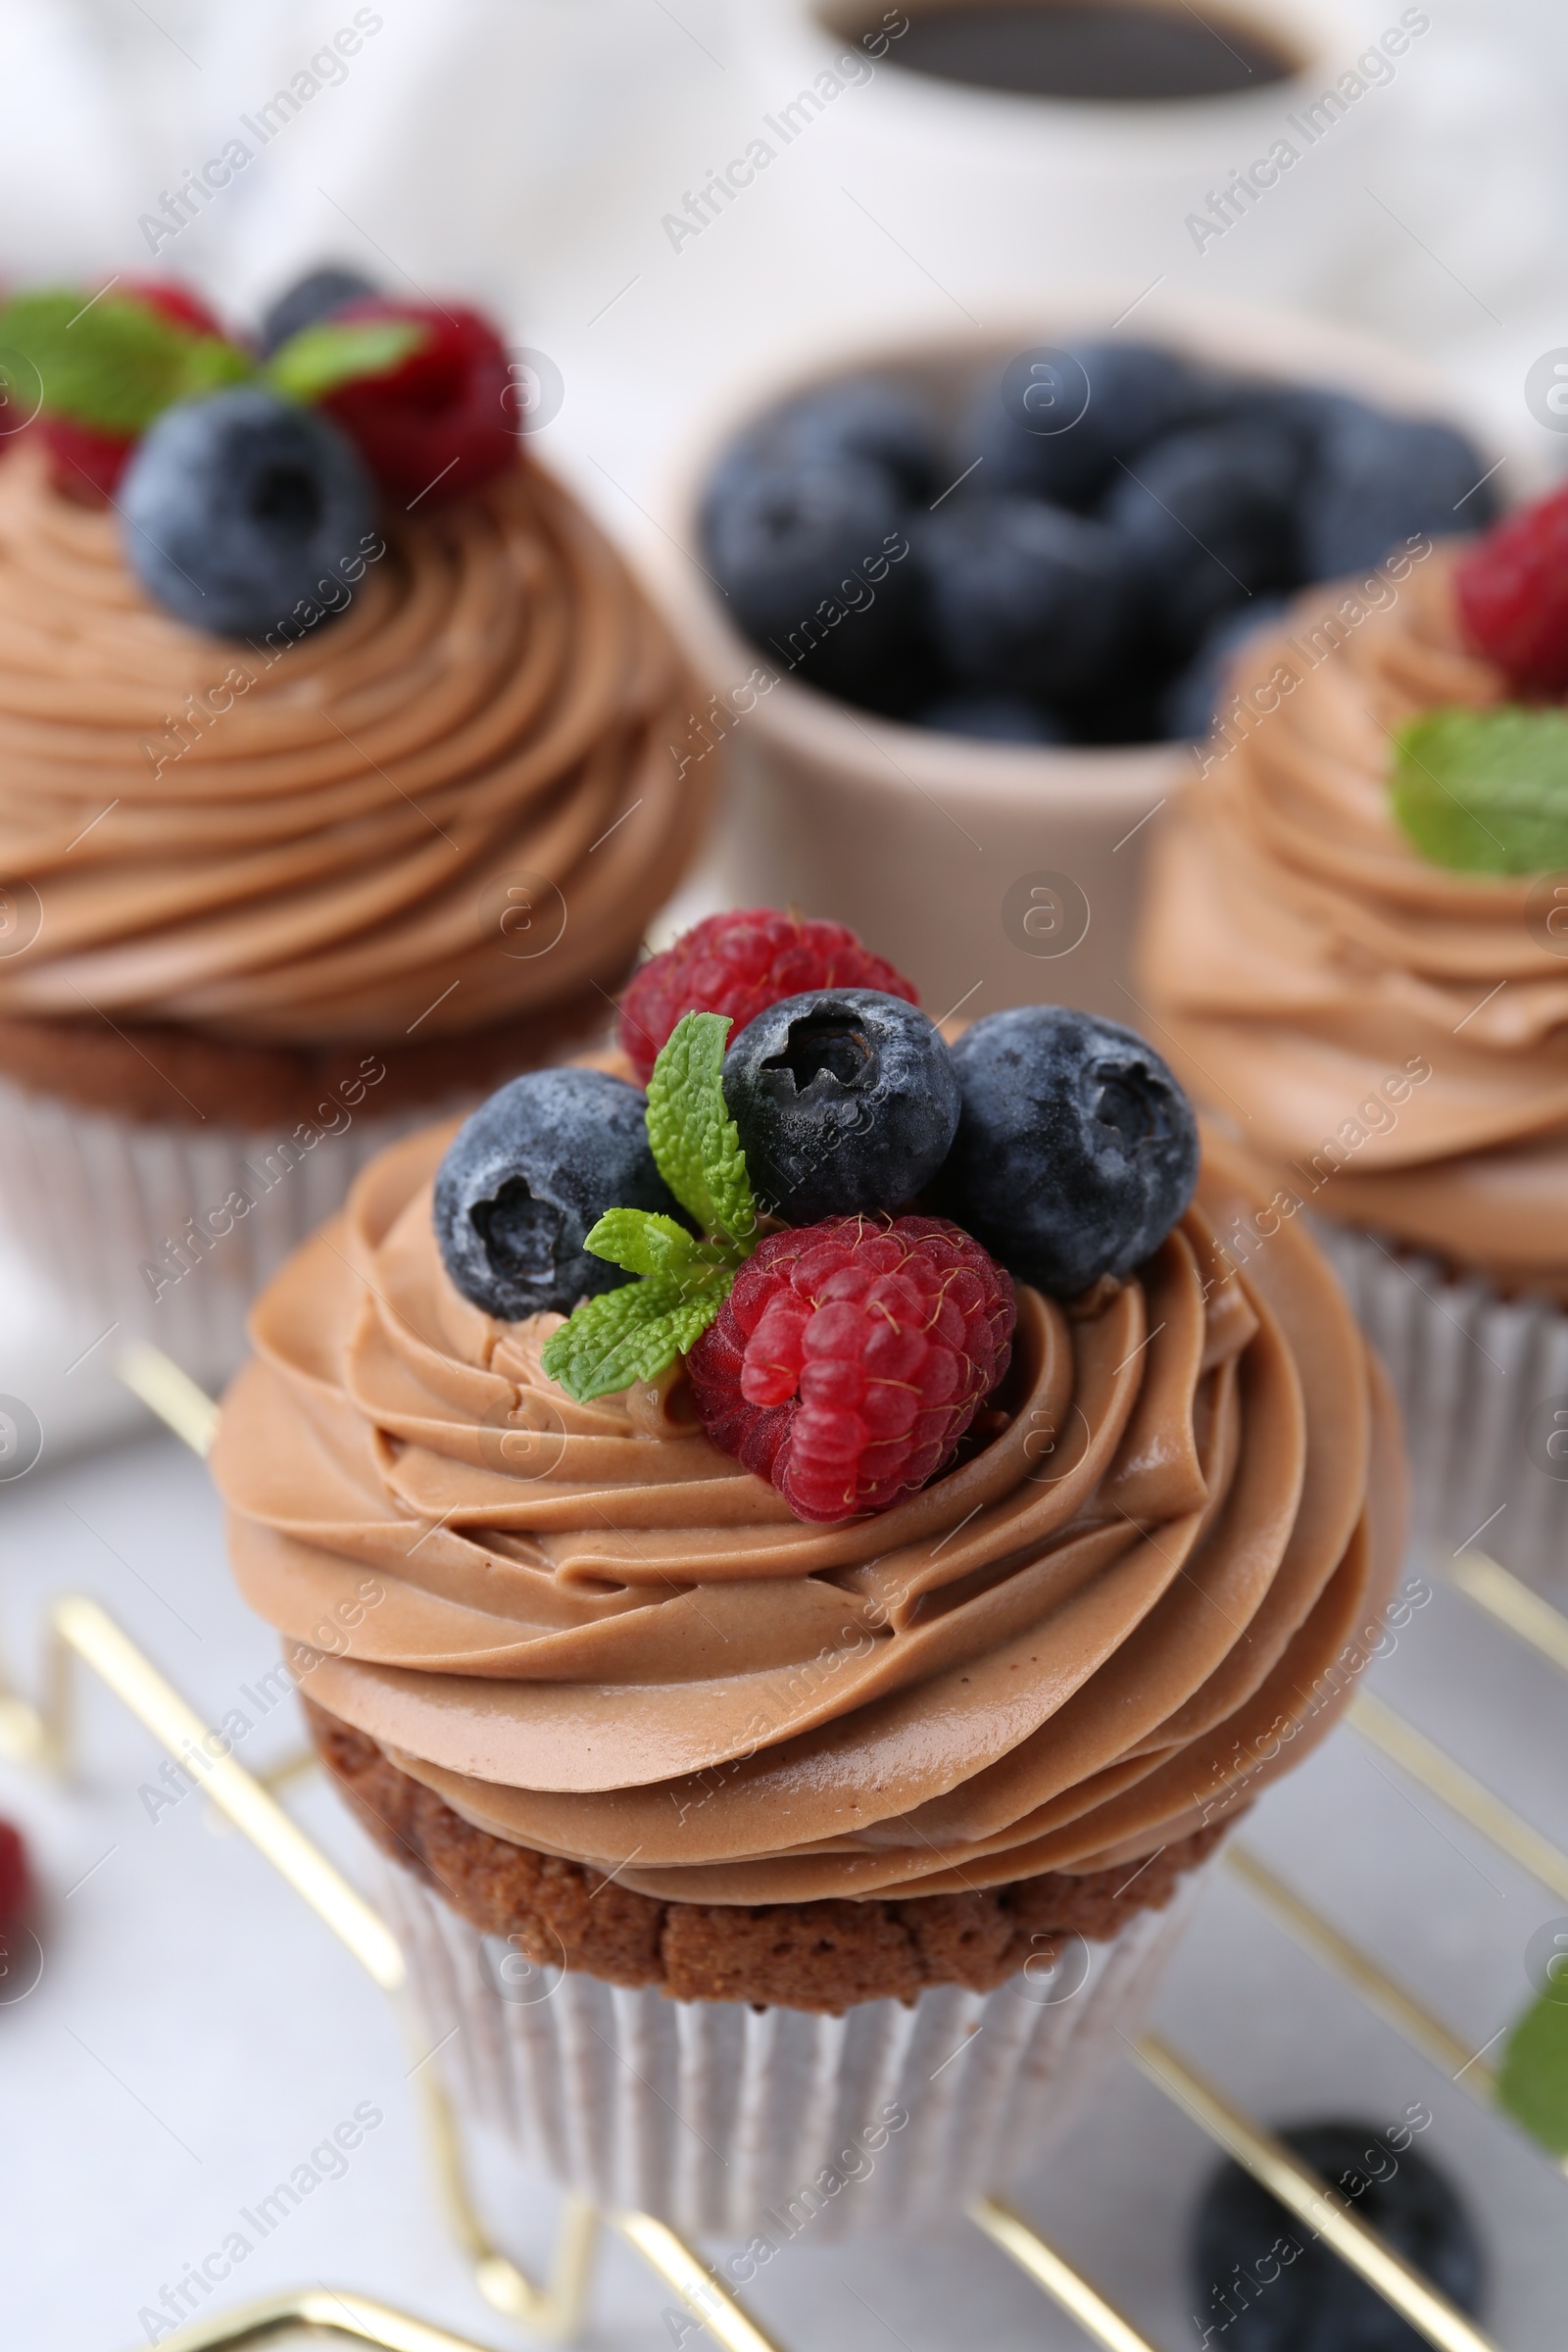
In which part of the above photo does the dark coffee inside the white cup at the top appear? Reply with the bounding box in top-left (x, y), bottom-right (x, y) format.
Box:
top-left (889, 0), bottom-right (1298, 101)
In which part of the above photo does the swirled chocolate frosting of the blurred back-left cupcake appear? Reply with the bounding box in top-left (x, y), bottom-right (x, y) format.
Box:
top-left (0, 442), bottom-right (703, 1047)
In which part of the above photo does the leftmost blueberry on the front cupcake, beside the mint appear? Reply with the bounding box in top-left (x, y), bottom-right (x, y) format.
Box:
top-left (435, 1070), bottom-right (689, 1322)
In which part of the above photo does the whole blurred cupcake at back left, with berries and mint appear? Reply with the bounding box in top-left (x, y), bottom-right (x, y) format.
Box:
top-left (0, 280), bottom-right (710, 1378)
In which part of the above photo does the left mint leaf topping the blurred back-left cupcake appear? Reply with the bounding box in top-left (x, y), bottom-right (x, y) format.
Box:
top-left (0, 287), bottom-right (256, 433)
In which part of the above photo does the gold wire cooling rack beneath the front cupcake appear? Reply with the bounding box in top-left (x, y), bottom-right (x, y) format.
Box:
top-left (0, 1348), bottom-right (1568, 2352)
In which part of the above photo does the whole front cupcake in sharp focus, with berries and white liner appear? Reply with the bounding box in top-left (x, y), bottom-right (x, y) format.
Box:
top-left (212, 915), bottom-right (1403, 2258)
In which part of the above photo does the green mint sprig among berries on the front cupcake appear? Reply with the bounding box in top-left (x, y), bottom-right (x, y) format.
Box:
top-left (541, 1013), bottom-right (757, 1404)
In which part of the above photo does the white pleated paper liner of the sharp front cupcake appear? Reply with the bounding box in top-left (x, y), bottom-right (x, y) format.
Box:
top-left (383, 1863), bottom-right (1203, 2251)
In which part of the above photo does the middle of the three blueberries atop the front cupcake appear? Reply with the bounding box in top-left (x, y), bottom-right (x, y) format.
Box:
top-left (724, 988), bottom-right (959, 1225)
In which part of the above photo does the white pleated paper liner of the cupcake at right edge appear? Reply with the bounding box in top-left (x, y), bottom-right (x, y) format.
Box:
top-left (1316, 1223), bottom-right (1568, 1601)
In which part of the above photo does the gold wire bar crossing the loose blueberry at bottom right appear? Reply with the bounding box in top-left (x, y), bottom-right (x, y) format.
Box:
top-left (1133, 2034), bottom-right (1497, 2352)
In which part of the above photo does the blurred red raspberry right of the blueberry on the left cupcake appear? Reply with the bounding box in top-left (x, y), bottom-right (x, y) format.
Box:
top-left (322, 294), bottom-right (517, 504)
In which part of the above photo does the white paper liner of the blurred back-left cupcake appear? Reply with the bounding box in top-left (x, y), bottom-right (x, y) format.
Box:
top-left (0, 1080), bottom-right (432, 1386)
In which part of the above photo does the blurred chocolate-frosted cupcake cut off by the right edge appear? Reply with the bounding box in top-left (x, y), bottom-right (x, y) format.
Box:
top-left (1140, 494), bottom-right (1568, 1590)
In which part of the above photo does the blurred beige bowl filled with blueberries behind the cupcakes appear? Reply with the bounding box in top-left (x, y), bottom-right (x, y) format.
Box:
top-left (665, 289), bottom-right (1497, 1021)
